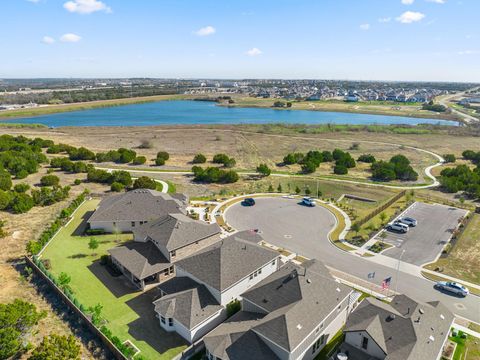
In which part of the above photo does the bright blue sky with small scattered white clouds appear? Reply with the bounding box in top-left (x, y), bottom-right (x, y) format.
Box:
top-left (0, 0), bottom-right (480, 82)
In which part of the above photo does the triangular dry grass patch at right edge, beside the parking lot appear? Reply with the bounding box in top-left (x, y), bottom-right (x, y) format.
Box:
top-left (426, 214), bottom-right (480, 284)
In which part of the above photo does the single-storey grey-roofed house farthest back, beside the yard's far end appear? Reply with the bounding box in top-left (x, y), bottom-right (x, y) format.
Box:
top-left (87, 189), bottom-right (188, 232)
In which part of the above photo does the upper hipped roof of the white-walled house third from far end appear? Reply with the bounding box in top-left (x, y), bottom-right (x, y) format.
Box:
top-left (176, 235), bottom-right (279, 292)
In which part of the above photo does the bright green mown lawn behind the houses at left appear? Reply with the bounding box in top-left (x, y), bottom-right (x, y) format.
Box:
top-left (41, 199), bottom-right (186, 359)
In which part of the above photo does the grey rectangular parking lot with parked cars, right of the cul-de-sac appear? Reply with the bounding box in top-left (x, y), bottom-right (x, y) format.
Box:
top-left (382, 203), bottom-right (467, 265)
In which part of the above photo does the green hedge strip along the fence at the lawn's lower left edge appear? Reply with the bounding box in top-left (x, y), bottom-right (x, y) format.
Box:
top-left (25, 255), bottom-right (130, 360)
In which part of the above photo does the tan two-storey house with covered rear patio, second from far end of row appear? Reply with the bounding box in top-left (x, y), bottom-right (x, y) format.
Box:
top-left (108, 213), bottom-right (221, 290)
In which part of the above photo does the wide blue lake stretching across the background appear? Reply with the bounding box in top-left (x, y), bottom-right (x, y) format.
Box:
top-left (3, 100), bottom-right (457, 127)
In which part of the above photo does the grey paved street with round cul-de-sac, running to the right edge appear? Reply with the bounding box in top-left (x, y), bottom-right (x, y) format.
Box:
top-left (225, 198), bottom-right (480, 323)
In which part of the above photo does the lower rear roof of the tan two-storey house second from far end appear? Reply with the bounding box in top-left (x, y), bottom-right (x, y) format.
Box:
top-left (108, 241), bottom-right (171, 280)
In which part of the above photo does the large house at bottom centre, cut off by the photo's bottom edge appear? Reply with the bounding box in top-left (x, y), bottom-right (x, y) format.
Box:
top-left (203, 260), bottom-right (359, 360)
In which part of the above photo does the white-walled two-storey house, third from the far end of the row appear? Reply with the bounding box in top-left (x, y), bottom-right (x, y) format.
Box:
top-left (153, 233), bottom-right (280, 342)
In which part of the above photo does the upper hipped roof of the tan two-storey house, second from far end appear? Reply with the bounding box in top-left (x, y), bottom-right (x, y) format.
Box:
top-left (133, 214), bottom-right (221, 251)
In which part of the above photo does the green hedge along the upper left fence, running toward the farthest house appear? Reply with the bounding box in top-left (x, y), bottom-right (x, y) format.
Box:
top-left (27, 190), bottom-right (89, 255)
